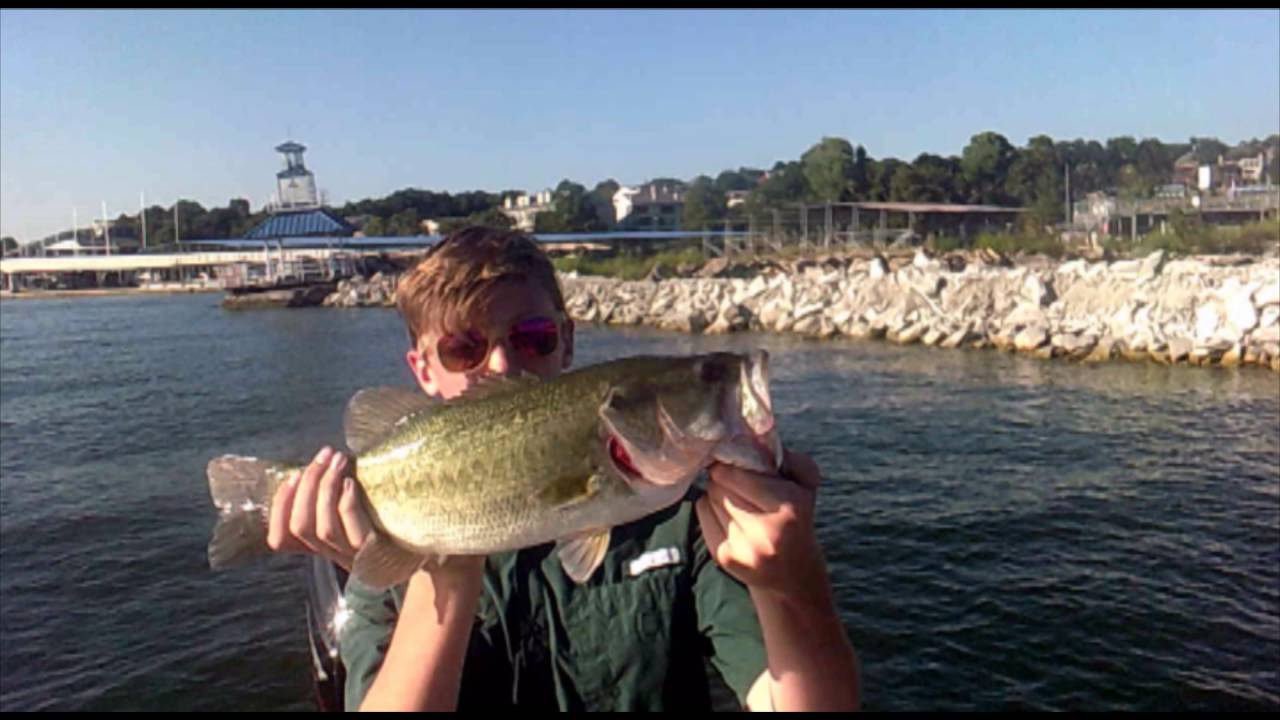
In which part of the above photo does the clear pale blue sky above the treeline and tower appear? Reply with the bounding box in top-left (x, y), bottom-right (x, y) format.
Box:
top-left (0, 10), bottom-right (1280, 243)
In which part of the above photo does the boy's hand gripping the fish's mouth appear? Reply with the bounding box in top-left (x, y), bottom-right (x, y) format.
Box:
top-left (696, 451), bottom-right (829, 602)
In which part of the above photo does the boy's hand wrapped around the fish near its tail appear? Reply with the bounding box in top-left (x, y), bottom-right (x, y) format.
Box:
top-left (266, 447), bottom-right (372, 570)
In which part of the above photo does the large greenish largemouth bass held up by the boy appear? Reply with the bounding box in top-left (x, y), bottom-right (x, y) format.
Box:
top-left (209, 351), bottom-right (782, 588)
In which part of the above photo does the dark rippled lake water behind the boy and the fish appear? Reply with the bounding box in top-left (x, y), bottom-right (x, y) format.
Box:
top-left (0, 295), bottom-right (1280, 710)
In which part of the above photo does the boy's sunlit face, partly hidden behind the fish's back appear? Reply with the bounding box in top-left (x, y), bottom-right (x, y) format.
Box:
top-left (404, 279), bottom-right (573, 400)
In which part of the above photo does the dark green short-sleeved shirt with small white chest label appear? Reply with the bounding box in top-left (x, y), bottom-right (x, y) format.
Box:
top-left (340, 489), bottom-right (765, 710)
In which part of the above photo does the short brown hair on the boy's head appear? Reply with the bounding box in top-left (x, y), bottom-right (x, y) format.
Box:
top-left (396, 227), bottom-right (564, 347)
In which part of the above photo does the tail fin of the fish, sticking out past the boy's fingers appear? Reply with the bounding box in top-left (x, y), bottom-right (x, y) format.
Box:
top-left (209, 455), bottom-right (288, 570)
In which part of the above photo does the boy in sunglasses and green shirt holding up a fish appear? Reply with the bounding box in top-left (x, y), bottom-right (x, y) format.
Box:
top-left (269, 228), bottom-right (860, 710)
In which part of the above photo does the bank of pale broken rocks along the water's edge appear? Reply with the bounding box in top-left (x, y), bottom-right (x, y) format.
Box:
top-left (324, 252), bottom-right (1280, 372)
